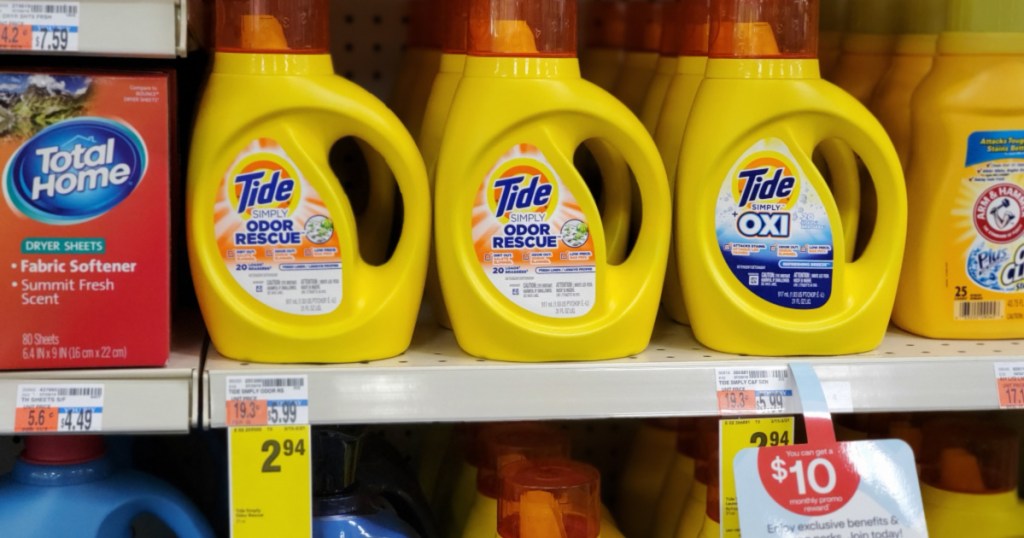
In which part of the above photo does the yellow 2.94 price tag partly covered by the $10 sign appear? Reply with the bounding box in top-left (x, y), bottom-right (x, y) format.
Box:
top-left (719, 417), bottom-right (795, 537)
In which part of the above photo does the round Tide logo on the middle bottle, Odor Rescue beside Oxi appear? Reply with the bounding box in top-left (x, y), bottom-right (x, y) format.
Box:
top-left (487, 159), bottom-right (558, 222)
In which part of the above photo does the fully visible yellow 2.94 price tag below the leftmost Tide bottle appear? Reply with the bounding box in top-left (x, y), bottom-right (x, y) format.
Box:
top-left (227, 425), bottom-right (312, 538)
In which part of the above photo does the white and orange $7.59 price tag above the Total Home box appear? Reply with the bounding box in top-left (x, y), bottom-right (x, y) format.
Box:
top-left (0, 1), bottom-right (81, 52)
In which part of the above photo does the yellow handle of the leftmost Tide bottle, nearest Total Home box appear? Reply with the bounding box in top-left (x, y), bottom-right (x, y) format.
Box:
top-left (316, 78), bottom-right (431, 299)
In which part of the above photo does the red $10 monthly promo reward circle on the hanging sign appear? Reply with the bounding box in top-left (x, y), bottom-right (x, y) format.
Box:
top-left (758, 443), bottom-right (860, 515)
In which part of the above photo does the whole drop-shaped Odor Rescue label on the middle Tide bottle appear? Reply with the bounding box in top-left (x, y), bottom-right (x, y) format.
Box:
top-left (472, 144), bottom-right (597, 318)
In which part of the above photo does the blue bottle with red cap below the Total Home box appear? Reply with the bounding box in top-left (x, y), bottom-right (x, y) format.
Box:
top-left (0, 437), bottom-right (214, 538)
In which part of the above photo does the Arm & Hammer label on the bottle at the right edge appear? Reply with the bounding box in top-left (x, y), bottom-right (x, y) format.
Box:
top-left (945, 131), bottom-right (1024, 321)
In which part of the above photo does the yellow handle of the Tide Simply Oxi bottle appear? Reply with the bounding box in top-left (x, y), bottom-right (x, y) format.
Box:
top-left (821, 111), bottom-right (907, 289)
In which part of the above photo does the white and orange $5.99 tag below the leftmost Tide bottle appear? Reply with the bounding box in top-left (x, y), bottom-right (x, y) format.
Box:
top-left (225, 375), bottom-right (309, 426)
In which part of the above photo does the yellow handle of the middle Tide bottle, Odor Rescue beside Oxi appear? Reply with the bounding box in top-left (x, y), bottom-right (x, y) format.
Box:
top-left (584, 102), bottom-right (673, 297)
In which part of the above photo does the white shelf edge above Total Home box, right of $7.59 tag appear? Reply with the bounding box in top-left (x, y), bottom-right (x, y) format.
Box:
top-left (1, 0), bottom-right (188, 57)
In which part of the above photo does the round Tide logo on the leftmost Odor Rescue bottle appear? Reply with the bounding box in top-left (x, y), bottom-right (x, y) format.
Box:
top-left (227, 153), bottom-right (302, 218)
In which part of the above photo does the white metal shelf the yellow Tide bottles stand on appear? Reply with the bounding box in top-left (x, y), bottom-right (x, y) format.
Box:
top-left (204, 322), bottom-right (1024, 427)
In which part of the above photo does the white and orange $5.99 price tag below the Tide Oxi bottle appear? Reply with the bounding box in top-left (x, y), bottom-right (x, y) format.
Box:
top-left (715, 366), bottom-right (796, 415)
